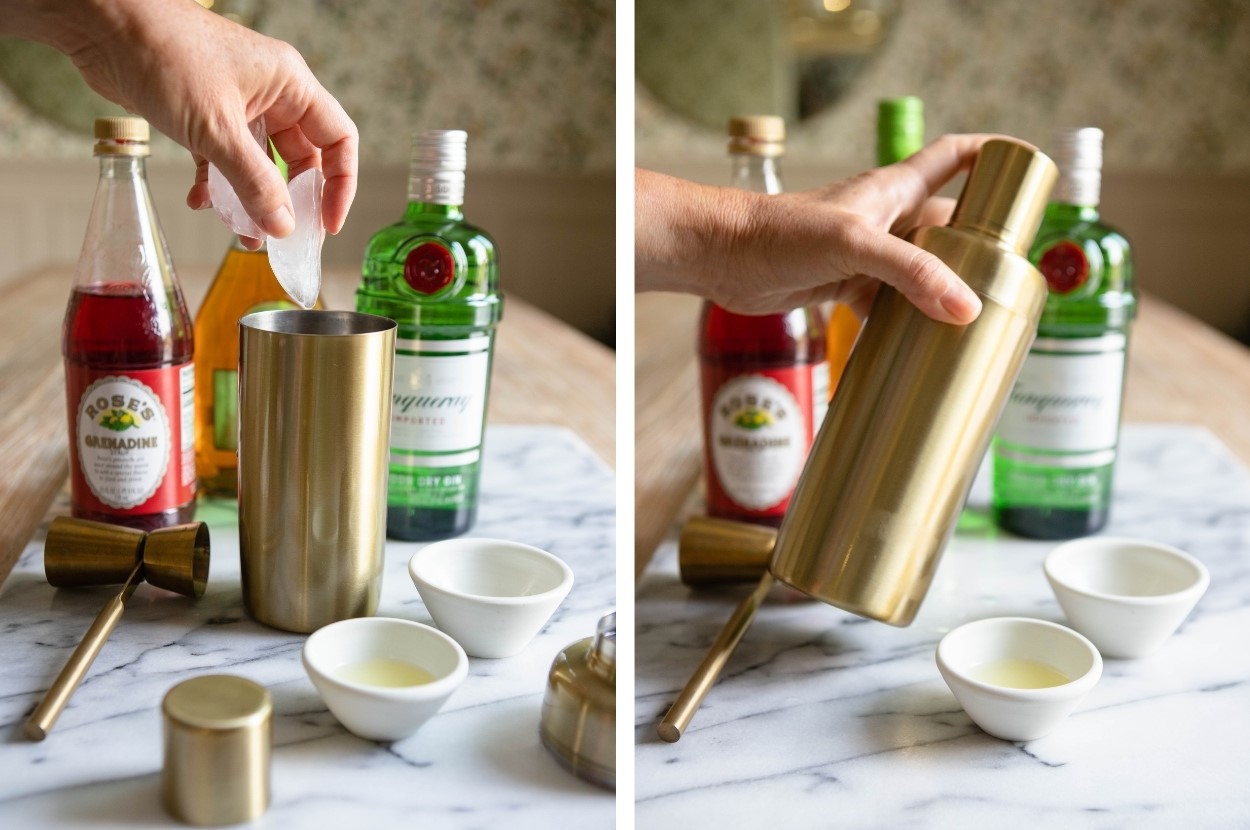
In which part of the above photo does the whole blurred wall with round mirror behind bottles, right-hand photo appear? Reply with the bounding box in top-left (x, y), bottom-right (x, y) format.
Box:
top-left (635, 0), bottom-right (1250, 343)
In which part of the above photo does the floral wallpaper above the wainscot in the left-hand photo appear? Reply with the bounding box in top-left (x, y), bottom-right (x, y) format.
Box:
top-left (0, 0), bottom-right (616, 173)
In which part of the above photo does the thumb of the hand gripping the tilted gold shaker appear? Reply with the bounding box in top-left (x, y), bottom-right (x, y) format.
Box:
top-left (845, 230), bottom-right (981, 325)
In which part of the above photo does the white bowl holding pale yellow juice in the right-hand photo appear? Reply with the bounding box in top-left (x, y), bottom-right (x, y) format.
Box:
top-left (938, 616), bottom-right (1103, 741)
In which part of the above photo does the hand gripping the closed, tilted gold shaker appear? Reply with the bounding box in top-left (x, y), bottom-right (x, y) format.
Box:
top-left (635, 135), bottom-right (995, 324)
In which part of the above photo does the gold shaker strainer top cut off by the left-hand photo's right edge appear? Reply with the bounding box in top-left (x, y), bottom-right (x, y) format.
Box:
top-left (539, 611), bottom-right (616, 789)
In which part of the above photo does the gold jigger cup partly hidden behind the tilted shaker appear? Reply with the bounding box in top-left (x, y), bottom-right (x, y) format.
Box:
top-left (678, 516), bottom-right (778, 588)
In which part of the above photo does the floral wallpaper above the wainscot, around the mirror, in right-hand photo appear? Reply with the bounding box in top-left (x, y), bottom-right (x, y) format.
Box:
top-left (635, 0), bottom-right (1250, 174)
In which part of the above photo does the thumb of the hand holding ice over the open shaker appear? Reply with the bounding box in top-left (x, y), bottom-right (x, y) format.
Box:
top-left (203, 119), bottom-right (295, 238)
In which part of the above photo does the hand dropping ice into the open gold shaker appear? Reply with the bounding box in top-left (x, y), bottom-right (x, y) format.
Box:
top-left (71, 0), bottom-right (359, 238)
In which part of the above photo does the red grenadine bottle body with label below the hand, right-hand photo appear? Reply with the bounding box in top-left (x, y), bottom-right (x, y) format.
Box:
top-left (699, 303), bottom-right (829, 526)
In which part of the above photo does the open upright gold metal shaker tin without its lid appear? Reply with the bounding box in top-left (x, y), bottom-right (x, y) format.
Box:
top-left (239, 310), bottom-right (396, 634)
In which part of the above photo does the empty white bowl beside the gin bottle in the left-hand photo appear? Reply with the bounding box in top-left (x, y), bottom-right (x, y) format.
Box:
top-left (408, 539), bottom-right (573, 658)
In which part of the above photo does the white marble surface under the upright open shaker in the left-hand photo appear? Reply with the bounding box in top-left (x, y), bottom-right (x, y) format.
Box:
top-left (0, 428), bottom-right (615, 830)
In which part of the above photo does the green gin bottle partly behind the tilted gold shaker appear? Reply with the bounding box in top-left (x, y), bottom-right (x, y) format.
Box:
top-left (993, 128), bottom-right (1138, 539)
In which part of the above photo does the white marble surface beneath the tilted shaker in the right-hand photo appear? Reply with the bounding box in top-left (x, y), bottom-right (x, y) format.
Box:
top-left (635, 425), bottom-right (1250, 830)
